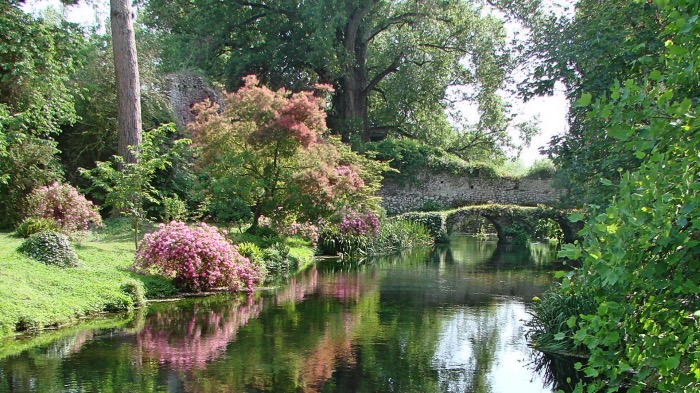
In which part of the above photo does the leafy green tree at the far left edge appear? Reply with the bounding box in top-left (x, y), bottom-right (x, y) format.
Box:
top-left (0, 2), bottom-right (84, 226)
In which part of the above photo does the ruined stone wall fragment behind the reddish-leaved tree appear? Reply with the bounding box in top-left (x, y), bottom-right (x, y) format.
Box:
top-left (168, 73), bottom-right (222, 128)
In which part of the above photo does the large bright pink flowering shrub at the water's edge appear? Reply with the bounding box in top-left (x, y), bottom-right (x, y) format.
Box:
top-left (133, 221), bottom-right (263, 291)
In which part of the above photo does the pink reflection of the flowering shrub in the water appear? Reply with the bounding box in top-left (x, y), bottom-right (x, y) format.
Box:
top-left (136, 296), bottom-right (263, 370)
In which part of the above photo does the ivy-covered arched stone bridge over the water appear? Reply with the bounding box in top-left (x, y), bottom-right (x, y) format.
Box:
top-left (398, 204), bottom-right (583, 243)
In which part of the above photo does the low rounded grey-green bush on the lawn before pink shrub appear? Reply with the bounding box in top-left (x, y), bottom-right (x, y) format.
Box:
top-left (17, 231), bottom-right (80, 267)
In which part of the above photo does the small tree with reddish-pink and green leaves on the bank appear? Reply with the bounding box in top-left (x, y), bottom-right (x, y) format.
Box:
top-left (188, 76), bottom-right (381, 230)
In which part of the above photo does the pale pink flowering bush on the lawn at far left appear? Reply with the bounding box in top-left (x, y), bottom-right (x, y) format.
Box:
top-left (27, 182), bottom-right (102, 233)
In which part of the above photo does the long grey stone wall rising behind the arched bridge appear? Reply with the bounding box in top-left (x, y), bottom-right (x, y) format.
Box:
top-left (380, 172), bottom-right (559, 214)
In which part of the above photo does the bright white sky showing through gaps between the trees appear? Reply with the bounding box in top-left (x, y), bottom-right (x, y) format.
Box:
top-left (25, 0), bottom-right (575, 166)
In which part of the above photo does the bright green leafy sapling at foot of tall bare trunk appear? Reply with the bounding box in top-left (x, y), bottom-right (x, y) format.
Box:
top-left (81, 124), bottom-right (189, 247)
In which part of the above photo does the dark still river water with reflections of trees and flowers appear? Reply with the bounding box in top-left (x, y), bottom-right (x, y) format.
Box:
top-left (0, 238), bottom-right (552, 393)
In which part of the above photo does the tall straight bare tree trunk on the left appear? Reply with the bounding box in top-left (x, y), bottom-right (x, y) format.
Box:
top-left (110, 0), bottom-right (141, 163)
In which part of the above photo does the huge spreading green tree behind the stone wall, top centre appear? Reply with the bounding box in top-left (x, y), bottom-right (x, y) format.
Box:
top-left (146, 0), bottom-right (509, 150)
